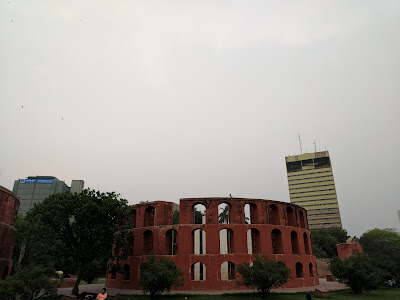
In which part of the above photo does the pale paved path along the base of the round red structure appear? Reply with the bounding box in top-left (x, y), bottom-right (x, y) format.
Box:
top-left (58, 278), bottom-right (346, 295)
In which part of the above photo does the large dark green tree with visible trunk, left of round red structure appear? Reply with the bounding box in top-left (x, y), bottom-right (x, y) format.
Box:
top-left (26, 189), bottom-right (131, 295)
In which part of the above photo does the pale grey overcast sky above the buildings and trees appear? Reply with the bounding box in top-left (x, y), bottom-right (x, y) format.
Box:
top-left (0, 0), bottom-right (400, 235)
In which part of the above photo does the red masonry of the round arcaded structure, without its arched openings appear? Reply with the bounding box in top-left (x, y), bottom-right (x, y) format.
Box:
top-left (106, 198), bottom-right (319, 290)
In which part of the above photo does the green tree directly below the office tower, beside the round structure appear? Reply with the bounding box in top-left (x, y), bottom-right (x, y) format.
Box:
top-left (311, 227), bottom-right (347, 258)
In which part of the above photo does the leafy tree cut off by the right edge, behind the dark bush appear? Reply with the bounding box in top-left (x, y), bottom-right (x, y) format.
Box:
top-left (360, 228), bottom-right (400, 282)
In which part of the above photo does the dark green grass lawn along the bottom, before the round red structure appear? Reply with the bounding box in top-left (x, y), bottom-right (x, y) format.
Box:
top-left (116, 288), bottom-right (400, 300)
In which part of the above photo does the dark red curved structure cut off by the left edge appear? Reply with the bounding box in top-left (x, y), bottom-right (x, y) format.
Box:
top-left (0, 186), bottom-right (19, 279)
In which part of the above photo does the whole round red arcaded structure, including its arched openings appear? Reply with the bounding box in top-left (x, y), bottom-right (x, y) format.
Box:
top-left (106, 198), bottom-right (319, 290)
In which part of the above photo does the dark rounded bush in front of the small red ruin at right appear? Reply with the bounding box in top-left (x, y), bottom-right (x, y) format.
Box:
top-left (329, 253), bottom-right (382, 294)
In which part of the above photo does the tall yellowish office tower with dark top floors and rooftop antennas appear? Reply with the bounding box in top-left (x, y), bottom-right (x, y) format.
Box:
top-left (285, 151), bottom-right (342, 229)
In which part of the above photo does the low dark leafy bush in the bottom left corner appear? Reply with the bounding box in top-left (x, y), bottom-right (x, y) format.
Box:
top-left (0, 265), bottom-right (57, 300)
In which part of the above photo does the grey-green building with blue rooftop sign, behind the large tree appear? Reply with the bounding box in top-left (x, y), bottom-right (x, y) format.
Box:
top-left (13, 176), bottom-right (84, 215)
